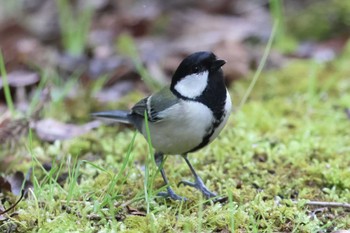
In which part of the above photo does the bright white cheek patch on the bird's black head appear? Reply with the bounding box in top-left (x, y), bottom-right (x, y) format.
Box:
top-left (175, 71), bottom-right (209, 99)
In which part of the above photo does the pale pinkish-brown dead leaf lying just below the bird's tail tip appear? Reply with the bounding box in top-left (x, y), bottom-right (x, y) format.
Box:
top-left (34, 119), bottom-right (101, 142)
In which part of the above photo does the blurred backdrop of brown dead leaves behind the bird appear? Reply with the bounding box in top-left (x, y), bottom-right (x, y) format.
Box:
top-left (0, 0), bottom-right (350, 109)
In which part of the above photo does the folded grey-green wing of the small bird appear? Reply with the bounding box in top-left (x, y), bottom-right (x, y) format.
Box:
top-left (131, 87), bottom-right (179, 122)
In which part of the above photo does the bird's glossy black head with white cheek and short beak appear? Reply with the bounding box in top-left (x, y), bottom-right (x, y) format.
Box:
top-left (170, 52), bottom-right (226, 99)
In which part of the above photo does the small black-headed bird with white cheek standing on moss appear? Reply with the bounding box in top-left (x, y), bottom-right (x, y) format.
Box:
top-left (92, 51), bottom-right (231, 200)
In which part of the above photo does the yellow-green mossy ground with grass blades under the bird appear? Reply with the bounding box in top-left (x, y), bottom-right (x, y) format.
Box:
top-left (0, 50), bottom-right (350, 232)
